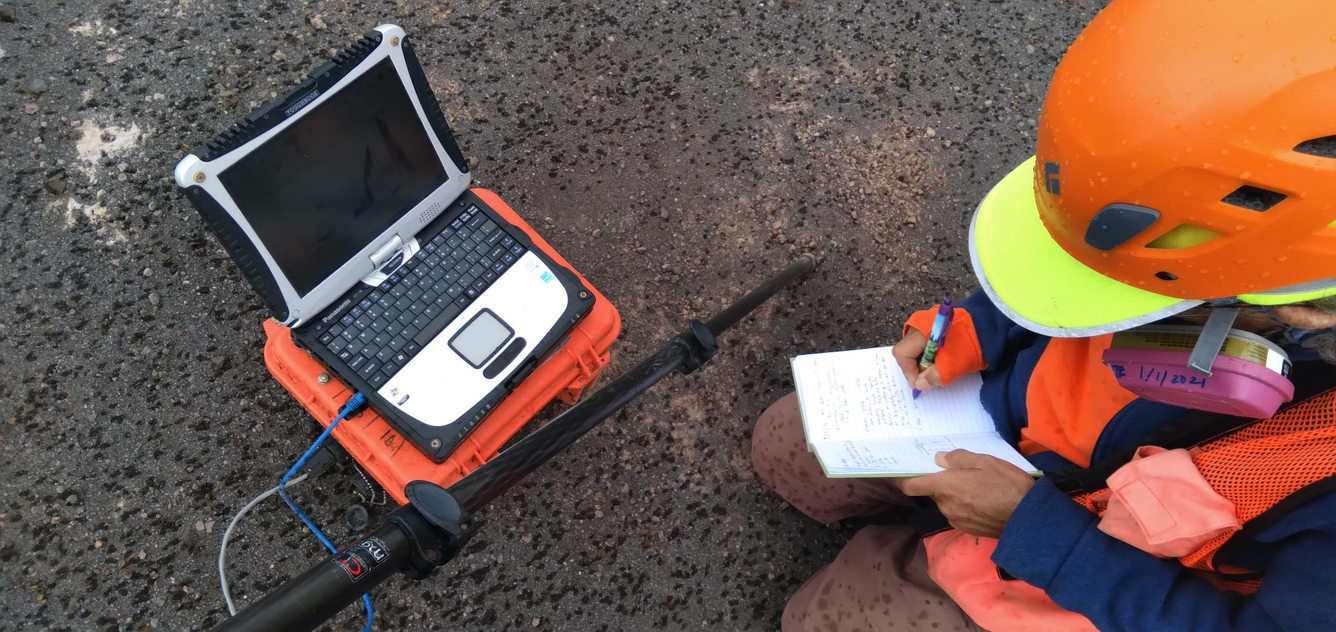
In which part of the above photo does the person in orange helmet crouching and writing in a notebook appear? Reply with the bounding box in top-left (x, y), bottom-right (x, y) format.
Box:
top-left (752, 0), bottom-right (1336, 632)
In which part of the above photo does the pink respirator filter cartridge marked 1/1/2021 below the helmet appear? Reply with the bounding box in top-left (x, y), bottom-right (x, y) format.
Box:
top-left (1102, 325), bottom-right (1295, 418)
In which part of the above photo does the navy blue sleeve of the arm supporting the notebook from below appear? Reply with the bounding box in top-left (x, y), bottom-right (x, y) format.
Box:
top-left (993, 480), bottom-right (1336, 632)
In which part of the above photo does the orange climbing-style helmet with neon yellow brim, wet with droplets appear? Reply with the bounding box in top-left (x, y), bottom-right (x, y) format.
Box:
top-left (970, 0), bottom-right (1336, 337)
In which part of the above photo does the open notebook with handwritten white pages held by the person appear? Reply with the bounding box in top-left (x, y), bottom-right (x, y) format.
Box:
top-left (792, 347), bottom-right (1038, 478)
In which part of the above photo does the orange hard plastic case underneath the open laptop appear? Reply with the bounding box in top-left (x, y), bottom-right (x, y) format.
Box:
top-left (265, 188), bottom-right (621, 504)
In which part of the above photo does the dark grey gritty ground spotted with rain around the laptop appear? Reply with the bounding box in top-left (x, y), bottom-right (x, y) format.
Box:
top-left (0, 0), bottom-right (1101, 631)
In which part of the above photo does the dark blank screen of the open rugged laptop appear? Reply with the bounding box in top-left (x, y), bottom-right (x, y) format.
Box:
top-left (219, 59), bottom-right (448, 295)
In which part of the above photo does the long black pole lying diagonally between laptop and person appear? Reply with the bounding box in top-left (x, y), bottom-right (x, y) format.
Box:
top-left (215, 254), bottom-right (816, 632)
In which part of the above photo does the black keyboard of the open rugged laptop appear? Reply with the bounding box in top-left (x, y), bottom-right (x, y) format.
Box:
top-left (319, 206), bottom-right (525, 389)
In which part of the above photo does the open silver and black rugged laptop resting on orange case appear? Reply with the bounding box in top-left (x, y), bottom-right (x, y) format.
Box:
top-left (176, 25), bottom-right (595, 461)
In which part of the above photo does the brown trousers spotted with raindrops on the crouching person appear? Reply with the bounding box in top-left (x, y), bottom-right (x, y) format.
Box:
top-left (752, 394), bottom-right (981, 632)
